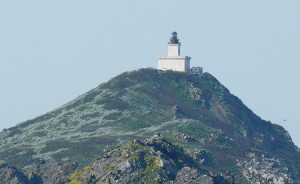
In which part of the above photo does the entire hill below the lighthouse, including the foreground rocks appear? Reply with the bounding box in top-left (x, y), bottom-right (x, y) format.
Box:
top-left (0, 69), bottom-right (300, 183)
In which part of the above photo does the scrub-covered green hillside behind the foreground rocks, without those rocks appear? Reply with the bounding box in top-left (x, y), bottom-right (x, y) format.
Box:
top-left (0, 69), bottom-right (300, 183)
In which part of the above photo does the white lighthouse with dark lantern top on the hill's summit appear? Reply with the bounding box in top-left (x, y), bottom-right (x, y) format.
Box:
top-left (157, 31), bottom-right (191, 72)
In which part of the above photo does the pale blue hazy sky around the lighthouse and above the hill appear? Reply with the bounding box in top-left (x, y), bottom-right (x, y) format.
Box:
top-left (0, 0), bottom-right (300, 146)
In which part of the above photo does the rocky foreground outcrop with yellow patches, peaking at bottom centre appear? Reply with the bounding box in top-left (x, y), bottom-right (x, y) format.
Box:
top-left (68, 136), bottom-right (234, 184)
